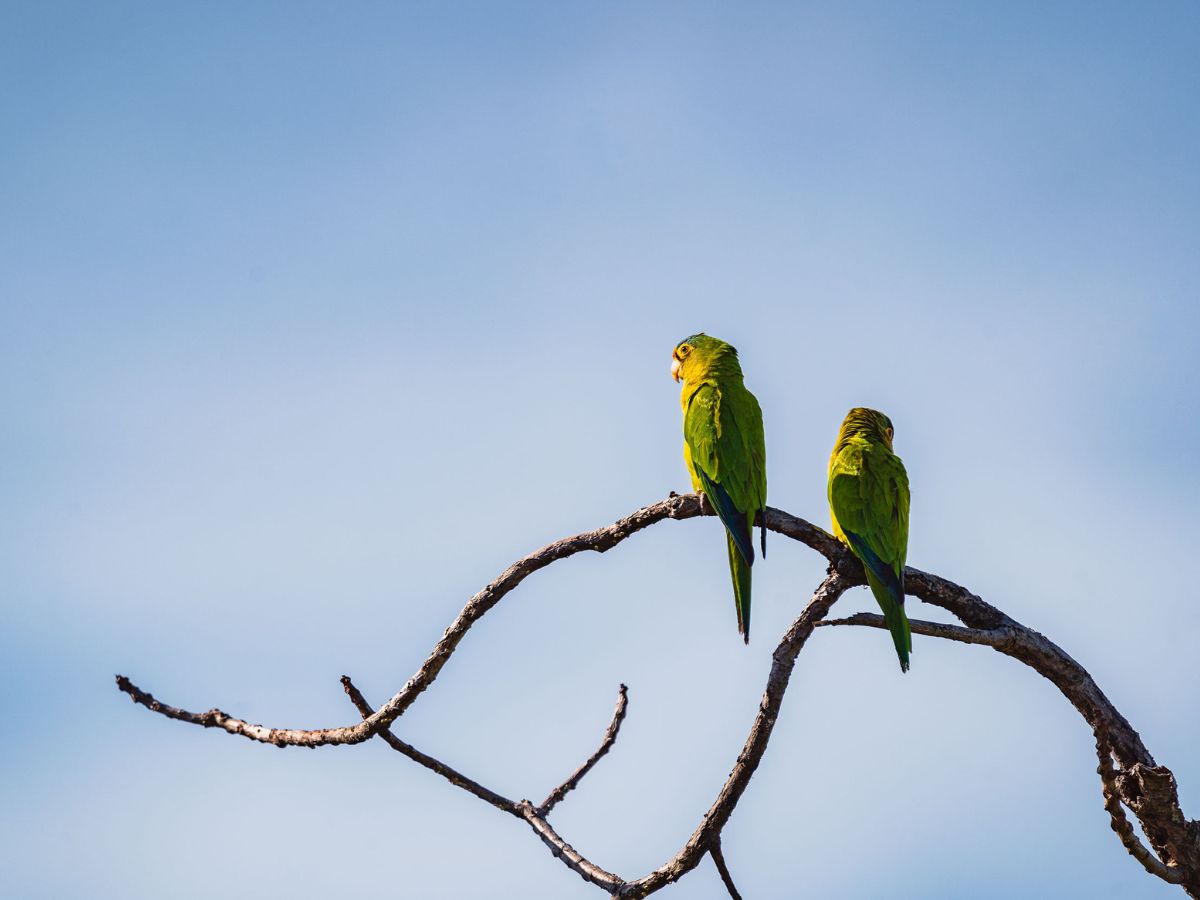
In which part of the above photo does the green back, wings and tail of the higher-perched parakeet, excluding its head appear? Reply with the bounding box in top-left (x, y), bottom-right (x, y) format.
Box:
top-left (683, 384), bottom-right (767, 642)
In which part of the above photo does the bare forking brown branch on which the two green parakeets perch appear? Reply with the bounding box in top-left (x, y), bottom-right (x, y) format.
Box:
top-left (116, 494), bottom-right (1200, 899)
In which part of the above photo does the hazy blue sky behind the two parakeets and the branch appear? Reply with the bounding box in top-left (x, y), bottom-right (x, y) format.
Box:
top-left (0, 1), bottom-right (1200, 900)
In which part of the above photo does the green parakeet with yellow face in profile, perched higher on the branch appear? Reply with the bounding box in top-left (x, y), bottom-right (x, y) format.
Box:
top-left (671, 334), bottom-right (767, 643)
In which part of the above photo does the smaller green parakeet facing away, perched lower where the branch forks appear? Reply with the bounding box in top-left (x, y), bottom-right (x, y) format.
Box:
top-left (829, 408), bottom-right (912, 672)
